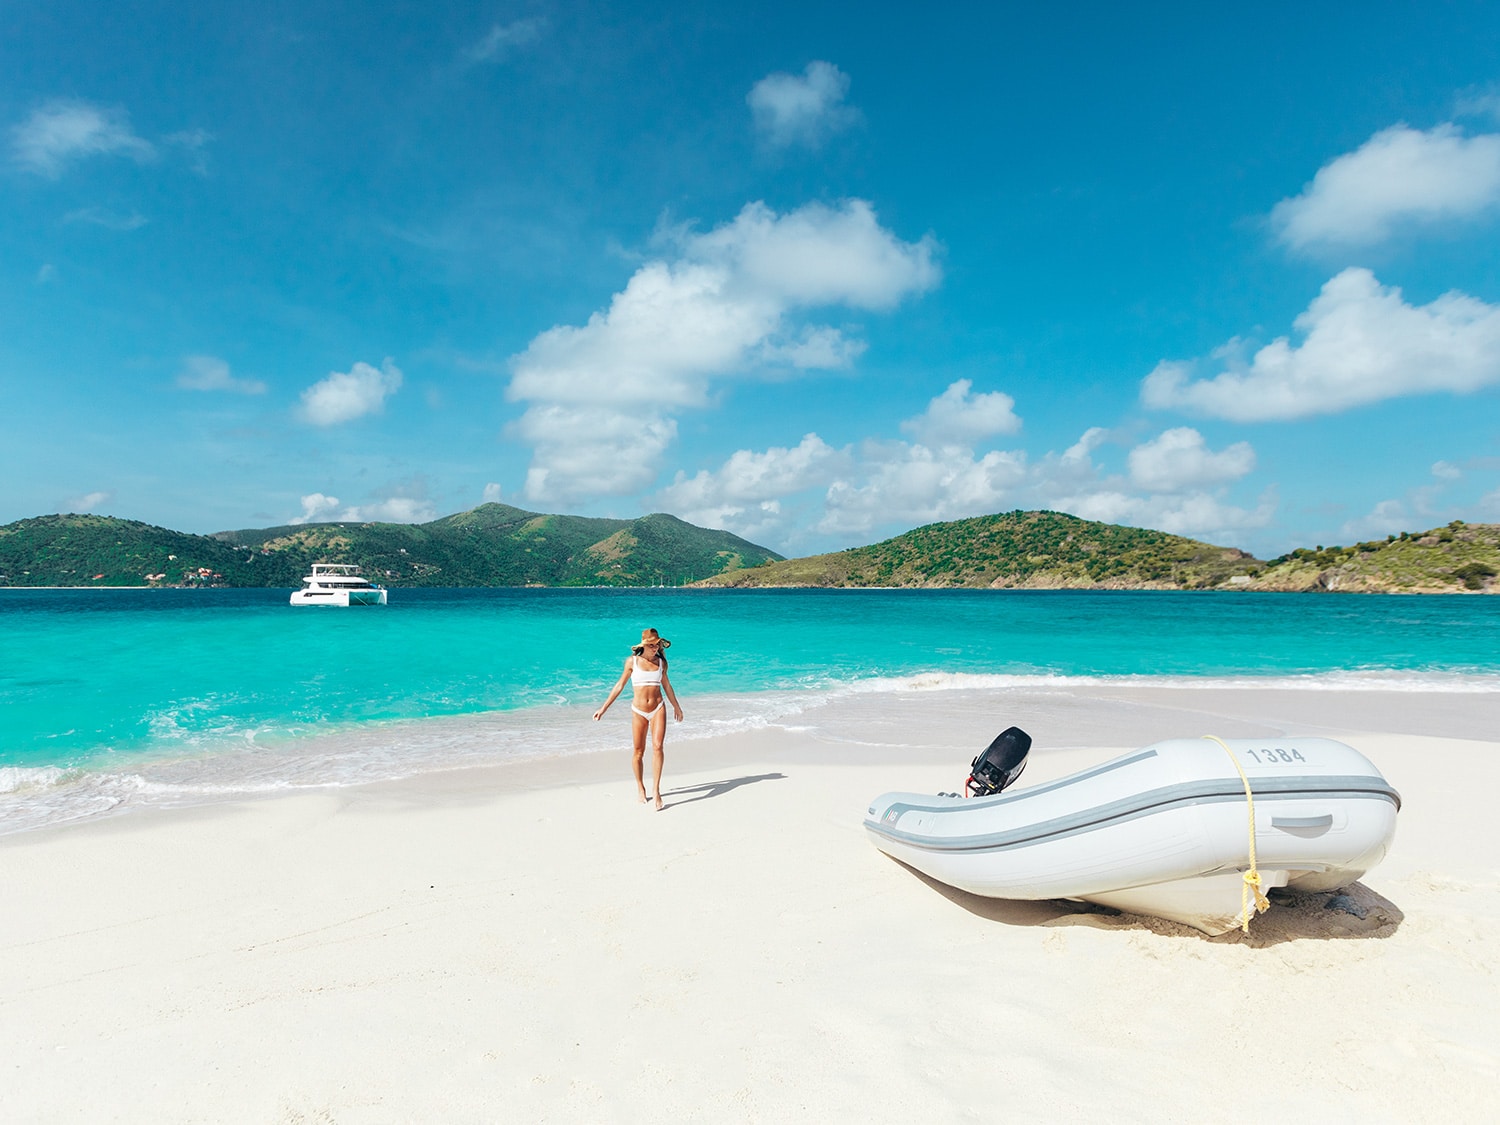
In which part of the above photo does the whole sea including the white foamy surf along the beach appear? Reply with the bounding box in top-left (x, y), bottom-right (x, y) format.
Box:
top-left (0, 590), bottom-right (1500, 833)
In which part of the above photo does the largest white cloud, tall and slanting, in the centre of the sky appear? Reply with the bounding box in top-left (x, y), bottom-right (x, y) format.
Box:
top-left (507, 200), bottom-right (941, 503)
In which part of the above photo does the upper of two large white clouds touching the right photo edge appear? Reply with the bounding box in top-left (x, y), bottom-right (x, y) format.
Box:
top-left (1271, 125), bottom-right (1500, 249)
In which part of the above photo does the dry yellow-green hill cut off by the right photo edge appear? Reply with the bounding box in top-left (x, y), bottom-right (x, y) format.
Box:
top-left (1250, 519), bottom-right (1500, 594)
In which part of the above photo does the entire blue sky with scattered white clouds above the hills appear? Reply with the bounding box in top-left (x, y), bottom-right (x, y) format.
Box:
top-left (0, 0), bottom-right (1500, 558)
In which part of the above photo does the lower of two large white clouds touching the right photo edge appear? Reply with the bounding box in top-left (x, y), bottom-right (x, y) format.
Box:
top-left (1142, 269), bottom-right (1500, 422)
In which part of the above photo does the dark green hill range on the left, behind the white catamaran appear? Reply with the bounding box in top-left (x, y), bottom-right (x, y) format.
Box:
top-left (0, 504), bottom-right (780, 587)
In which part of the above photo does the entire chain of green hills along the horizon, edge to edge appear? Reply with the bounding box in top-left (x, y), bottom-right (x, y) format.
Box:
top-left (0, 504), bottom-right (1500, 594)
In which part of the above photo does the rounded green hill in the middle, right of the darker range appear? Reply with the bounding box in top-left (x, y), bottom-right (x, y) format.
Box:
top-left (701, 512), bottom-right (1263, 590)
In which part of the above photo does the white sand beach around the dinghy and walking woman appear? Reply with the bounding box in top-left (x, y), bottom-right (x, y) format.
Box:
top-left (0, 687), bottom-right (1500, 1124)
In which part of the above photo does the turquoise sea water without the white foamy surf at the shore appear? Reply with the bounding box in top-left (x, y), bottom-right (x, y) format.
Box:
top-left (0, 590), bottom-right (1500, 768)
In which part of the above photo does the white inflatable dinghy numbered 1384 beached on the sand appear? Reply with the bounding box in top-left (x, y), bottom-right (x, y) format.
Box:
top-left (864, 729), bottom-right (1401, 935)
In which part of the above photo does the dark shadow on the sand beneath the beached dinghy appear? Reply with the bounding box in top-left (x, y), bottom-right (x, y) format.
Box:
top-left (894, 860), bottom-right (1406, 950)
